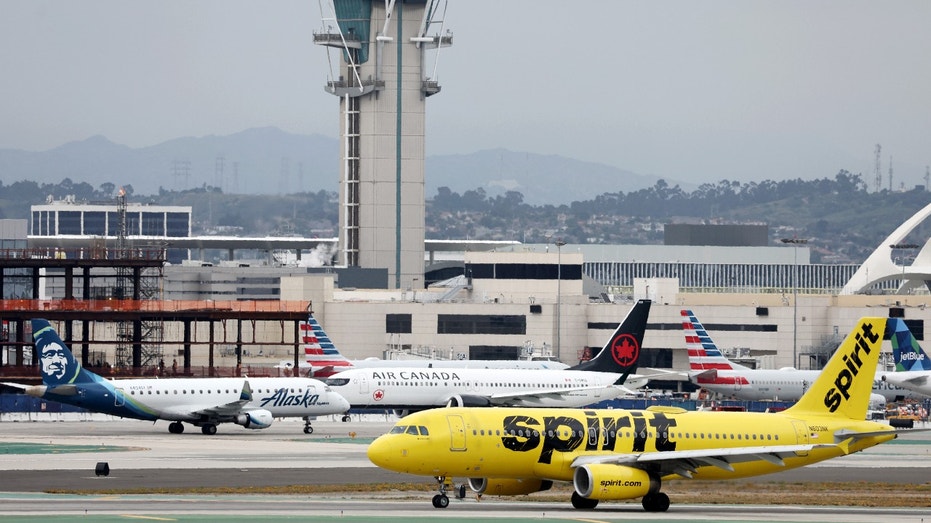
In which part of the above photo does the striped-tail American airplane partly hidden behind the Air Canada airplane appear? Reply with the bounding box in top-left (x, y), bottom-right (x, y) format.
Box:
top-left (276, 314), bottom-right (568, 378)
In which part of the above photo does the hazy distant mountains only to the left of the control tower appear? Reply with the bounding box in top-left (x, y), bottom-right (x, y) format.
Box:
top-left (0, 127), bottom-right (339, 194)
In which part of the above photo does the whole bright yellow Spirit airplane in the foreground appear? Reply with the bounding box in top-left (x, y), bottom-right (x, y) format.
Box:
top-left (368, 318), bottom-right (896, 512)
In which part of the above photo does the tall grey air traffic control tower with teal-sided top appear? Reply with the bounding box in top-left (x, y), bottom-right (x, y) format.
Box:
top-left (314, 0), bottom-right (452, 289)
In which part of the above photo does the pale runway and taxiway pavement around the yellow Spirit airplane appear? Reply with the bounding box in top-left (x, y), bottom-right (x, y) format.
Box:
top-left (0, 416), bottom-right (931, 522)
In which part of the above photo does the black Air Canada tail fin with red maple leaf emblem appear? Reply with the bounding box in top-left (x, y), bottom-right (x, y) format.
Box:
top-left (570, 300), bottom-right (653, 378)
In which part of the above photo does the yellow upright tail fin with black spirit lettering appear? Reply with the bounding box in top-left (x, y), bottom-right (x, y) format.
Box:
top-left (786, 318), bottom-right (887, 420)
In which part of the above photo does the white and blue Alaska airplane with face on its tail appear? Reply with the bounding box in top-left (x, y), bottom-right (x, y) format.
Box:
top-left (4, 320), bottom-right (349, 434)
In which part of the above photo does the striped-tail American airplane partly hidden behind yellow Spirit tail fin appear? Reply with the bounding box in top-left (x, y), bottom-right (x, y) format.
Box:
top-left (682, 310), bottom-right (916, 408)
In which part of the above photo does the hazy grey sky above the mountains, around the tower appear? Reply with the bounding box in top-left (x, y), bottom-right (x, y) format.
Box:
top-left (0, 0), bottom-right (931, 188)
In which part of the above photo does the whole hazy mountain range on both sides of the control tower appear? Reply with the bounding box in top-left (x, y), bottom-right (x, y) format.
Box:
top-left (0, 127), bottom-right (668, 205)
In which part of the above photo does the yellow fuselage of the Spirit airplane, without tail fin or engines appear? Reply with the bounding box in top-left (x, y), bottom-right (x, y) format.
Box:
top-left (369, 408), bottom-right (895, 481)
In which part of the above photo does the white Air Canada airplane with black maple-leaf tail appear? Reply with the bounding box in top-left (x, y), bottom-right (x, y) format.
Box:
top-left (326, 300), bottom-right (652, 415)
